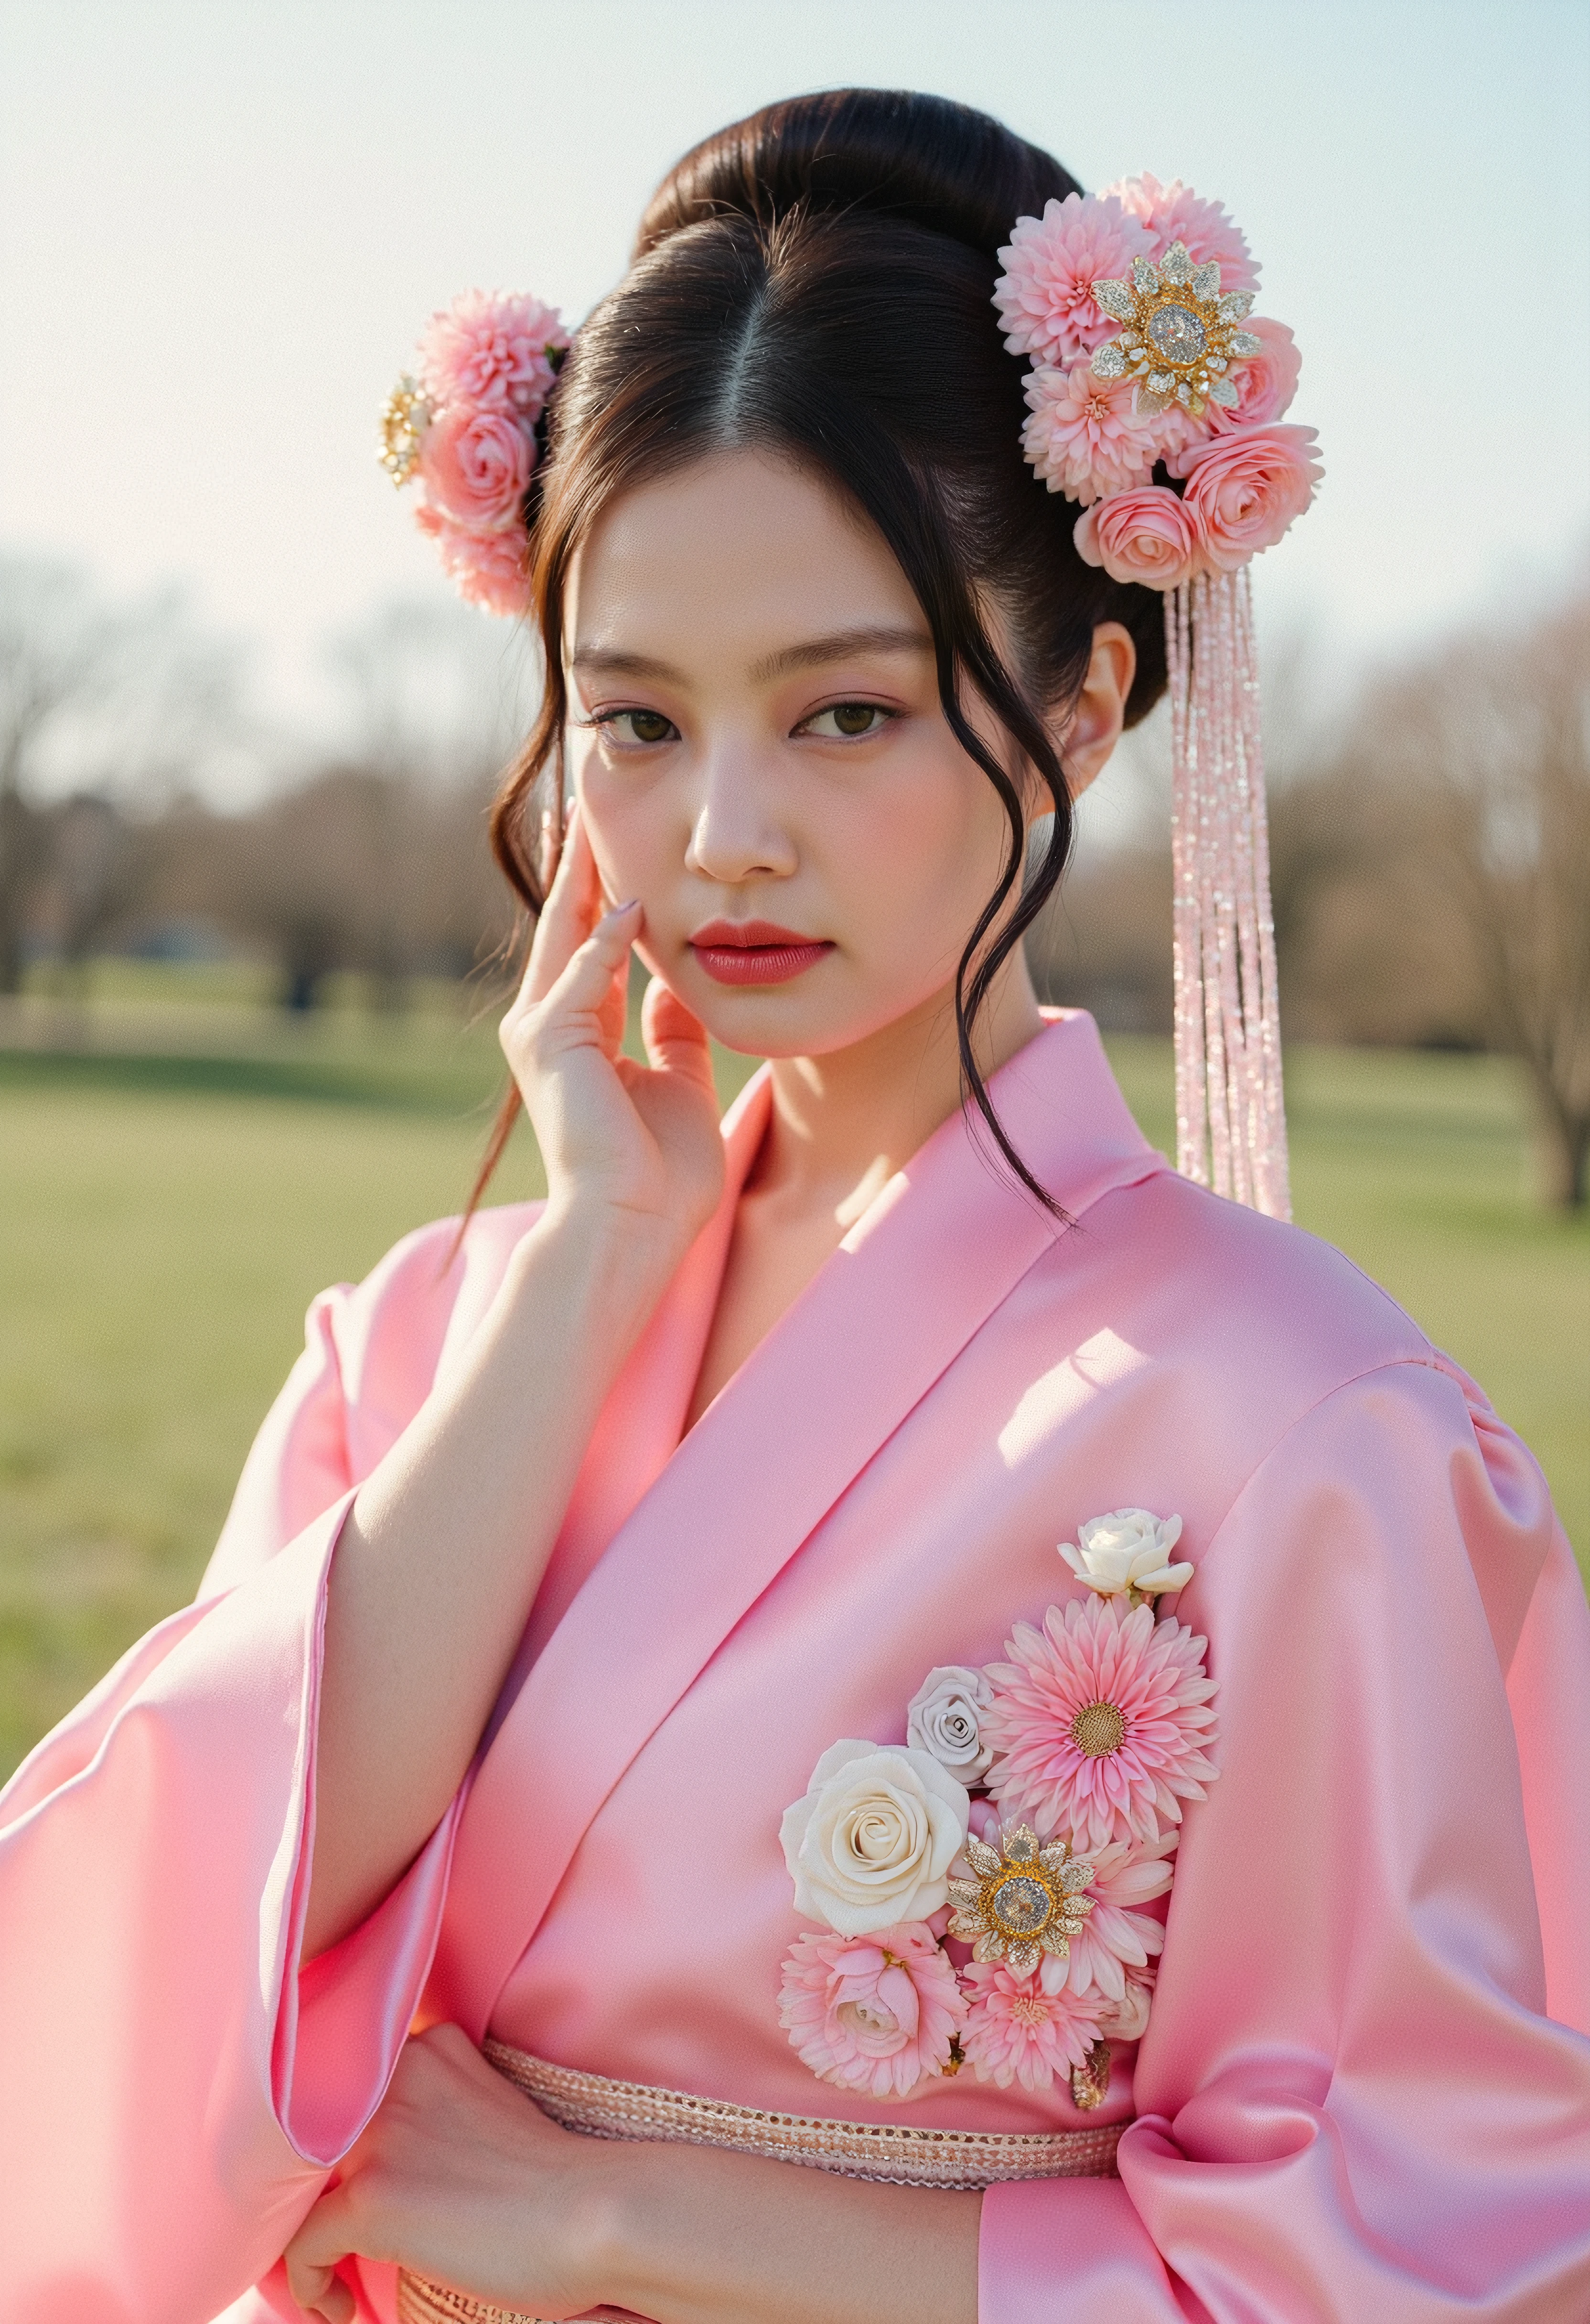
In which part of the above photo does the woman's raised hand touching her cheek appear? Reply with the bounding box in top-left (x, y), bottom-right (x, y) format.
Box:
top-left (502, 809), bottom-right (723, 1273)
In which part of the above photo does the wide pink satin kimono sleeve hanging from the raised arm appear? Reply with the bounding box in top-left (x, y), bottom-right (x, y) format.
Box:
top-left (0, 1229), bottom-right (497, 2324)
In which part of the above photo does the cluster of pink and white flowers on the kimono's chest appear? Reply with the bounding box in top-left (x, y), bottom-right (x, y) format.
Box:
top-left (779, 1508), bottom-right (1216, 2108)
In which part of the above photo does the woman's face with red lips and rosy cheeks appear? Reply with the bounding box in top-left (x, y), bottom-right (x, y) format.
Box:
top-left (565, 451), bottom-right (1130, 1057)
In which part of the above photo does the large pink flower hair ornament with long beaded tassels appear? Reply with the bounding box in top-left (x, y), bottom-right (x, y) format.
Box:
top-left (993, 174), bottom-right (1322, 1218)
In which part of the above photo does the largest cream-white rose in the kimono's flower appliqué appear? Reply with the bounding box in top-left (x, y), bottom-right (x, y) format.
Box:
top-left (779, 1736), bottom-right (972, 1936)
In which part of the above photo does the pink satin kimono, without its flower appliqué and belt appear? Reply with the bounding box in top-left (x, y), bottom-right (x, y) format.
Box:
top-left (0, 1016), bottom-right (1590, 2324)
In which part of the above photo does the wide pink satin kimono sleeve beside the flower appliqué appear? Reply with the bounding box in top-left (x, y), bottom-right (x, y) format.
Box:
top-left (978, 1364), bottom-right (1590, 2324)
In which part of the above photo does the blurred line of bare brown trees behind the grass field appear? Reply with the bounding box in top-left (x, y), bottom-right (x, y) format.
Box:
top-left (0, 560), bottom-right (1590, 1206)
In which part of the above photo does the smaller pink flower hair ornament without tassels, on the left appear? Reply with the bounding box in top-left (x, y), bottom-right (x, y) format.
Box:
top-left (376, 290), bottom-right (569, 616)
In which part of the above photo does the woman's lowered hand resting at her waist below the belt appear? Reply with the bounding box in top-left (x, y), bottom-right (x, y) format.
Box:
top-left (284, 2026), bottom-right (612, 2324)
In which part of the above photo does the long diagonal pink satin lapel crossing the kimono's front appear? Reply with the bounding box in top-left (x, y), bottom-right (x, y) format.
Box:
top-left (425, 1016), bottom-right (1167, 2041)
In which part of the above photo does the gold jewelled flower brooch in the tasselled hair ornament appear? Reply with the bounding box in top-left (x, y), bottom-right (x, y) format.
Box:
top-left (1093, 242), bottom-right (1265, 419)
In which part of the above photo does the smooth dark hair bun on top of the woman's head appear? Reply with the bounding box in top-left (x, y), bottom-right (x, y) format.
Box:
top-left (634, 88), bottom-right (1081, 260)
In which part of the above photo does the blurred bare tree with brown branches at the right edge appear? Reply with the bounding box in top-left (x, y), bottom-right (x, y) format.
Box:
top-left (1367, 590), bottom-right (1590, 1208)
